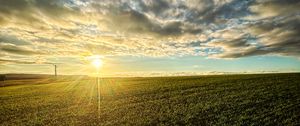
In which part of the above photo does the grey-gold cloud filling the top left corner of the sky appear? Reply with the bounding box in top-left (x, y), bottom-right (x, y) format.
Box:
top-left (0, 0), bottom-right (80, 30)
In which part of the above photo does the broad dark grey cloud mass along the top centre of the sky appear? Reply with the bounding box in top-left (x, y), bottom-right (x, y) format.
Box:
top-left (92, 0), bottom-right (251, 36)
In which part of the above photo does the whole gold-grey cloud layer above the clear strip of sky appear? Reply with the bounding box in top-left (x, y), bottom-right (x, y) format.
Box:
top-left (0, 0), bottom-right (300, 63)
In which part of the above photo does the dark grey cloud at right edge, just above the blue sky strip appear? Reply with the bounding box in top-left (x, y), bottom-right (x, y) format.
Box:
top-left (220, 16), bottom-right (300, 58)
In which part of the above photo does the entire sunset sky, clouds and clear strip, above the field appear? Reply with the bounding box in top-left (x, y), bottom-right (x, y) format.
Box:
top-left (0, 0), bottom-right (300, 76)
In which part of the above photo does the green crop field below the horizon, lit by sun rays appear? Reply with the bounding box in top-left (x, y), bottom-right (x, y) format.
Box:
top-left (0, 73), bottom-right (300, 125)
